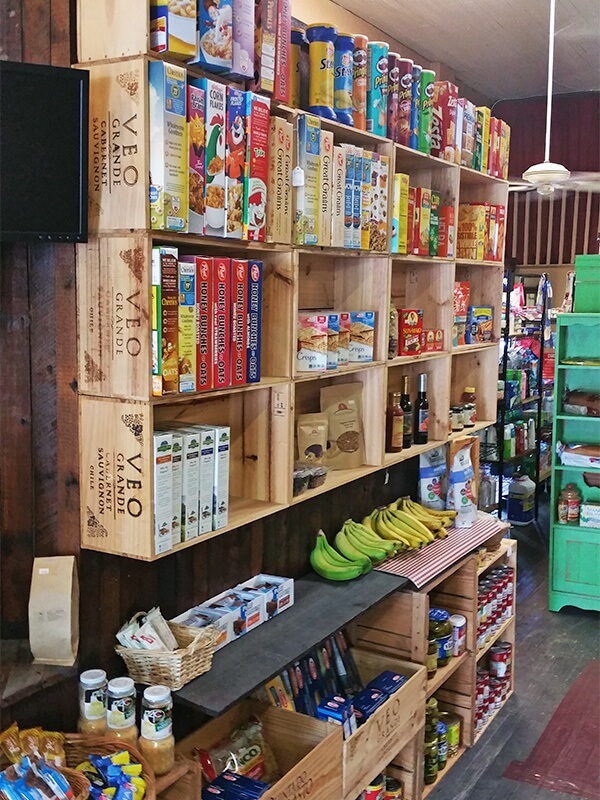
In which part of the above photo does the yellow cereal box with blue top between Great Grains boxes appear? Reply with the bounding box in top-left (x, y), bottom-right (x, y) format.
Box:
top-left (294, 114), bottom-right (321, 245)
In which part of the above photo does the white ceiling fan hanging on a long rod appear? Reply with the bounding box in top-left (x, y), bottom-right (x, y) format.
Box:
top-left (509, 0), bottom-right (600, 196)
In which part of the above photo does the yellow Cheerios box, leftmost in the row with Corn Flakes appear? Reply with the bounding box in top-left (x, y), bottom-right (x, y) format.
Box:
top-left (148, 61), bottom-right (189, 232)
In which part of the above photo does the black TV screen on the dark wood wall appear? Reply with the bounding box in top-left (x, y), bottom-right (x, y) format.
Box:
top-left (0, 61), bottom-right (89, 242)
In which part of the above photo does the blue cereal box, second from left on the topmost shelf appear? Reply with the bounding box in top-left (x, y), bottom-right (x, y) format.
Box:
top-left (194, 0), bottom-right (233, 73)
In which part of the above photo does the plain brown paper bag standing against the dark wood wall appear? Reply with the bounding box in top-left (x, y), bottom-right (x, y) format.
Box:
top-left (29, 556), bottom-right (79, 667)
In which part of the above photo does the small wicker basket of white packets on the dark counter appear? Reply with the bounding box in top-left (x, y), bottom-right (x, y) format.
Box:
top-left (115, 622), bottom-right (218, 691)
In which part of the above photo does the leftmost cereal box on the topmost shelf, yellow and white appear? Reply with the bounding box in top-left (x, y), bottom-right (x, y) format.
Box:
top-left (150, 0), bottom-right (198, 61)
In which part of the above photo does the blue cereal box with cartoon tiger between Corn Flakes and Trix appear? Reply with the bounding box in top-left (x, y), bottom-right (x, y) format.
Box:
top-left (225, 86), bottom-right (246, 239)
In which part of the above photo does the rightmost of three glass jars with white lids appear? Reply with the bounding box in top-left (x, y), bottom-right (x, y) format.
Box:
top-left (139, 686), bottom-right (175, 775)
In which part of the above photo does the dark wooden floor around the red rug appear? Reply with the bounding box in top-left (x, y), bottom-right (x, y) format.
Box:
top-left (429, 494), bottom-right (600, 800)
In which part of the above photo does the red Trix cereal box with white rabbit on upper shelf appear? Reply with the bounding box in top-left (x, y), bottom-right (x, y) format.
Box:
top-left (244, 92), bottom-right (271, 242)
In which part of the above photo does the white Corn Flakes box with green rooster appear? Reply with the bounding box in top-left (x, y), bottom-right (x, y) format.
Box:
top-left (200, 78), bottom-right (227, 236)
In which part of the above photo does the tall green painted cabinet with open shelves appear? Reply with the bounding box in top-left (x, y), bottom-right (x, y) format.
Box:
top-left (549, 313), bottom-right (600, 611)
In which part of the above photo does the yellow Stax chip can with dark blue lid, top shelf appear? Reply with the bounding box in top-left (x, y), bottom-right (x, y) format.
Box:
top-left (306, 23), bottom-right (337, 120)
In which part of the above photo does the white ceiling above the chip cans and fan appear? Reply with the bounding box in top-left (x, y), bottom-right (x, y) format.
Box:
top-left (336, 0), bottom-right (600, 101)
